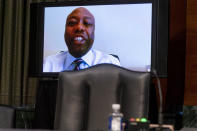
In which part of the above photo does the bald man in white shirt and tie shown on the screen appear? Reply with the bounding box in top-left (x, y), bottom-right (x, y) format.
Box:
top-left (43, 7), bottom-right (120, 72)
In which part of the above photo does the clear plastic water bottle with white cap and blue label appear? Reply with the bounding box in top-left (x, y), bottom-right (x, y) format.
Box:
top-left (108, 104), bottom-right (123, 131)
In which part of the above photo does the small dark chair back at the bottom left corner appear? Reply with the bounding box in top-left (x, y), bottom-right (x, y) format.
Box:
top-left (0, 105), bottom-right (15, 128)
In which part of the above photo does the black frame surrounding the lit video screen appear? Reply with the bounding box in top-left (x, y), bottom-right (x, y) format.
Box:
top-left (28, 0), bottom-right (159, 77)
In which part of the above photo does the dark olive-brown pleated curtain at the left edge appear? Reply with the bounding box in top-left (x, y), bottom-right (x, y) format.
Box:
top-left (0, 0), bottom-right (28, 105)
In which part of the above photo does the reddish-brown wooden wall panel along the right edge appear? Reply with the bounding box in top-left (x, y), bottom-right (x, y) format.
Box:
top-left (184, 0), bottom-right (197, 105)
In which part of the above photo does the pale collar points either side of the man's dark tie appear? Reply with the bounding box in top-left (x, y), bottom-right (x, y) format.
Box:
top-left (65, 49), bottom-right (93, 69)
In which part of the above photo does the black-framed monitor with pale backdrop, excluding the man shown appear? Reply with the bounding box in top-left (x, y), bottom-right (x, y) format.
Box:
top-left (29, 0), bottom-right (165, 75)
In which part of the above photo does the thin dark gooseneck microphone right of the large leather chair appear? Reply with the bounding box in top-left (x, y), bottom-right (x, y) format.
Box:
top-left (152, 69), bottom-right (163, 130)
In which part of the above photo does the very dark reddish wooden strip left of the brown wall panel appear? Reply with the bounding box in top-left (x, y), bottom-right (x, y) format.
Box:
top-left (166, 0), bottom-right (187, 110)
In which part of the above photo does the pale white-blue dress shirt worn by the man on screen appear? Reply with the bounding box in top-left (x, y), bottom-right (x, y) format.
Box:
top-left (43, 49), bottom-right (120, 72)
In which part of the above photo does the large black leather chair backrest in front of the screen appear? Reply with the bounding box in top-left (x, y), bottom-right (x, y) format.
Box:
top-left (54, 64), bottom-right (150, 131)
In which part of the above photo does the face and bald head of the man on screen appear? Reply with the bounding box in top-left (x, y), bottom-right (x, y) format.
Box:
top-left (64, 8), bottom-right (95, 57)
